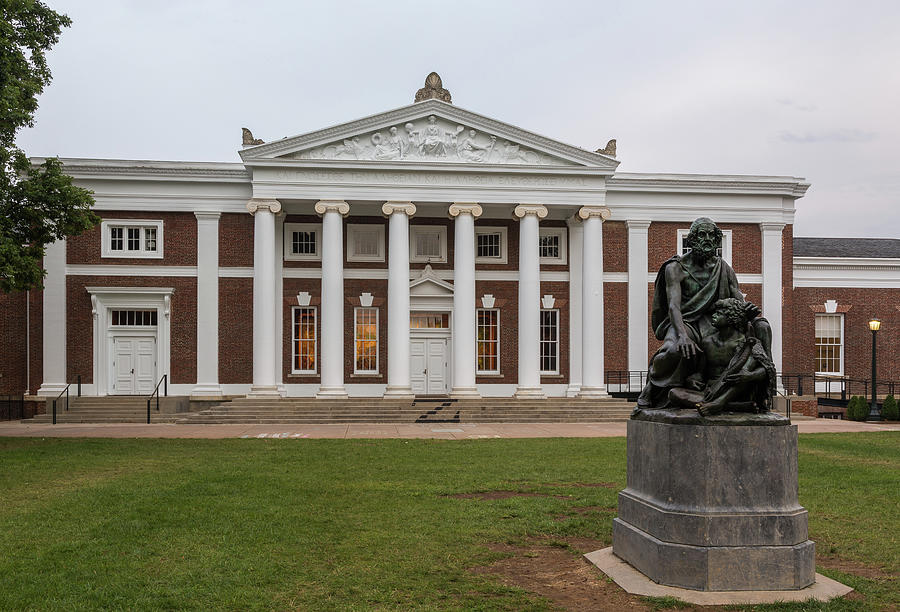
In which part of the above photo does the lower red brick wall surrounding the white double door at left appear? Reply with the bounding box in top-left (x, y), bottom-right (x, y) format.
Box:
top-left (66, 276), bottom-right (197, 384)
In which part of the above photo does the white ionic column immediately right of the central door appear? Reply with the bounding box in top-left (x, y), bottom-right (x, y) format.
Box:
top-left (450, 202), bottom-right (482, 397)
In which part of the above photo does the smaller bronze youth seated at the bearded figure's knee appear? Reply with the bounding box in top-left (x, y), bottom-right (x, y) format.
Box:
top-left (669, 298), bottom-right (776, 416)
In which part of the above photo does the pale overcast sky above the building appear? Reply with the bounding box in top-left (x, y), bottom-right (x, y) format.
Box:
top-left (19, 0), bottom-right (900, 238)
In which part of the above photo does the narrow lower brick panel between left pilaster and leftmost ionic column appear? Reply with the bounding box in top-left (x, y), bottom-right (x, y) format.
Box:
top-left (219, 278), bottom-right (253, 384)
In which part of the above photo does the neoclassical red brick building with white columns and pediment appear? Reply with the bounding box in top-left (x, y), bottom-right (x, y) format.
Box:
top-left (0, 79), bottom-right (900, 397)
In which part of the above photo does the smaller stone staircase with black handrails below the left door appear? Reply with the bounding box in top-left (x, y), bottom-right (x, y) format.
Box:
top-left (24, 395), bottom-right (184, 424)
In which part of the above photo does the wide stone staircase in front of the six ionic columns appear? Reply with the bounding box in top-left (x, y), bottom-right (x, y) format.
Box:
top-left (177, 398), bottom-right (634, 424)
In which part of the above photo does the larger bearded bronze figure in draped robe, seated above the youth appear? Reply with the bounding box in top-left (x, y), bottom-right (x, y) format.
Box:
top-left (636, 217), bottom-right (772, 412)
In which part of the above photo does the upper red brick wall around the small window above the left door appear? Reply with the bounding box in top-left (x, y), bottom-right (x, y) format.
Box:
top-left (66, 211), bottom-right (198, 266)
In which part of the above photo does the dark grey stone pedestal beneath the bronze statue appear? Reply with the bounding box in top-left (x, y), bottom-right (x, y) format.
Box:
top-left (613, 412), bottom-right (815, 591)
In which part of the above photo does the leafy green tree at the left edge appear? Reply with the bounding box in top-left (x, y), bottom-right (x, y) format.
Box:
top-left (0, 0), bottom-right (100, 292)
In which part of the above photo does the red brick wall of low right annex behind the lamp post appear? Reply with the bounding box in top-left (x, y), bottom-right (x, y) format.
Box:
top-left (784, 287), bottom-right (900, 380)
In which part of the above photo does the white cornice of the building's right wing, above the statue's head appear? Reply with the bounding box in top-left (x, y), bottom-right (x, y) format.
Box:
top-left (606, 172), bottom-right (810, 198)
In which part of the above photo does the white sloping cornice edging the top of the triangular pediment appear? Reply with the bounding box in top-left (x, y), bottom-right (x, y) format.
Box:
top-left (239, 100), bottom-right (619, 170)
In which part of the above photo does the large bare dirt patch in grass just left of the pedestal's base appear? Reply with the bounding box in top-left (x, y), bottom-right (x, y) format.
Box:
top-left (472, 538), bottom-right (652, 610)
